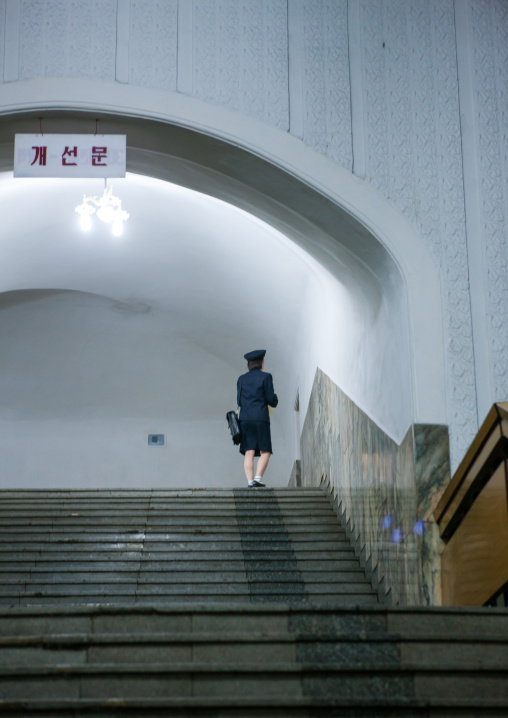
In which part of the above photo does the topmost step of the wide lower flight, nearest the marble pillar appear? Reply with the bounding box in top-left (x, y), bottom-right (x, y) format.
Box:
top-left (0, 602), bottom-right (508, 642)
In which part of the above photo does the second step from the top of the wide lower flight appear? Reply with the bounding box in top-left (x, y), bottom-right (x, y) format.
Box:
top-left (0, 632), bottom-right (508, 670)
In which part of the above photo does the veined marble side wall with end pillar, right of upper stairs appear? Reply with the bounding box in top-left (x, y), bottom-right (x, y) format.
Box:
top-left (301, 369), bottom-right (450, 605)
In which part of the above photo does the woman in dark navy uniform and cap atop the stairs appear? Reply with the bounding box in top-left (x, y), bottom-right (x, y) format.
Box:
top-left (236, 349), bottom-right (279, 488)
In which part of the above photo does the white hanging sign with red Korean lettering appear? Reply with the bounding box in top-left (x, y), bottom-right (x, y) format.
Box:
top-left (14, 134), bottom-right (127, 178)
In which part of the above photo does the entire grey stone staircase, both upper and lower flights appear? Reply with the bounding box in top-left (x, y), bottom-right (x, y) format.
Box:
top-left (0, 489), bottom-right (508, 718)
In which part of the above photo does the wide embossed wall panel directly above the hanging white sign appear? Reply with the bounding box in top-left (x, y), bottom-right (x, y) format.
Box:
top-left (19, 0), bottom-right (117, 82)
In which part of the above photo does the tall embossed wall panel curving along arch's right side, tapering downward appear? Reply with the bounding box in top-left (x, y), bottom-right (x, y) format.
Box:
top-left (360, 0), bottom-right (474, 466)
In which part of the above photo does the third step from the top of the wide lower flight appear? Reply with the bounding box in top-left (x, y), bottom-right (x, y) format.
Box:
top-left (0, 662), bottom-right (508, 701)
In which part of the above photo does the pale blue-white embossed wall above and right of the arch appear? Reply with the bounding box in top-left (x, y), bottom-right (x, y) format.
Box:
top-left (0, 0), bottom-right (508, 466)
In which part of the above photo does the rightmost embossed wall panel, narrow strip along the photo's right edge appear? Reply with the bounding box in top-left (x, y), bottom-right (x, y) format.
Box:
top-left (469, 0), bottom-right (508, 401)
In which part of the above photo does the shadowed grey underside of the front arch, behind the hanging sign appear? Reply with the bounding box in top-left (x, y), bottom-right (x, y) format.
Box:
top-left (0, 110), bottom-right (400, 296)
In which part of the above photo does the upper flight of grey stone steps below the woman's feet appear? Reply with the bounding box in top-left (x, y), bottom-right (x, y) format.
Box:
top-left (0, 489), bottom-right (377, 606)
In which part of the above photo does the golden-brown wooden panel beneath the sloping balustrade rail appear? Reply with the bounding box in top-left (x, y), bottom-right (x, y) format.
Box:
top-left (442, 462), bottom-right (508, 606)
